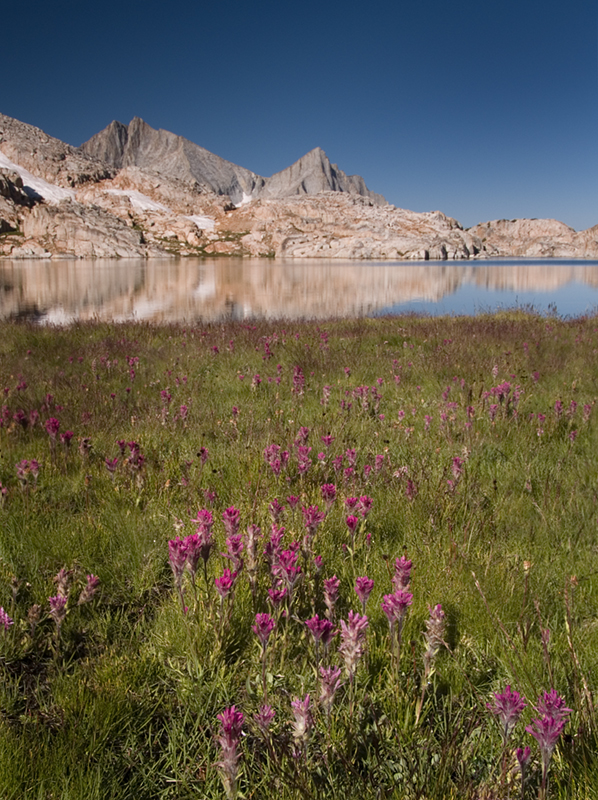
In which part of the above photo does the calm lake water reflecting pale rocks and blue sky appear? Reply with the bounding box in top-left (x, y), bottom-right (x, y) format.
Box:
top-left (0, 258), bottom-right (598, 324)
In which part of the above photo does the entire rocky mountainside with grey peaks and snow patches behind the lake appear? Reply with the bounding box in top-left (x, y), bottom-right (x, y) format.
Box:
top-left (0, 115), bottom-right (598, 260)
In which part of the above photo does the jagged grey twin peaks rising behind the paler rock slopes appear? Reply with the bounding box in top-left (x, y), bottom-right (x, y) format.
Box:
top-left (79, 117), bottom-right (386, 205)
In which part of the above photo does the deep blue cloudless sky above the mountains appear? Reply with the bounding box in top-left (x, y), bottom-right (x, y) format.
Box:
top-left (0, 0), bottom-right (598, 229)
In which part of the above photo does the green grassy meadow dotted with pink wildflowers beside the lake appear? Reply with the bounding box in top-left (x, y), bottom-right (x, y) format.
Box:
top-left (0, 311), bottom-right (598, 800)
